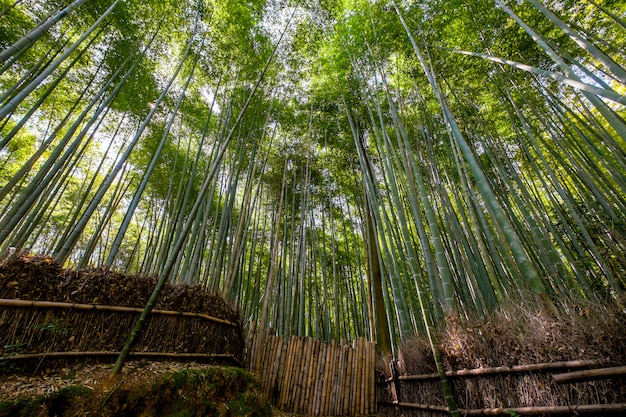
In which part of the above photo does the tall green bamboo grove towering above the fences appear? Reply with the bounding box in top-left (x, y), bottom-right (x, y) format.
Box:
top-left (0, 0), bottom-right (626, 353)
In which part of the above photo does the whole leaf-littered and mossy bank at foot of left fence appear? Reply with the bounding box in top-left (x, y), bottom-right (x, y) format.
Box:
top-left (0, 361), bottom-right (271, 417)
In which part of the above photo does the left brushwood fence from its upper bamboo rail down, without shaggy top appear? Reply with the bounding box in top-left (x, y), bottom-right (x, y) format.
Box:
top-left (0, 299), bottom-right (244, 372)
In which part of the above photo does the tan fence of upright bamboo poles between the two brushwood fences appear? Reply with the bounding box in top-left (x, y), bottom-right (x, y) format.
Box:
top-left (246, 333), bottom-right (376, 416)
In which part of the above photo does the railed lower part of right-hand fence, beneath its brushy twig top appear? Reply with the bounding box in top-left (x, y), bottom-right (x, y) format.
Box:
top-left (378, 360), bottom-right (626, 417)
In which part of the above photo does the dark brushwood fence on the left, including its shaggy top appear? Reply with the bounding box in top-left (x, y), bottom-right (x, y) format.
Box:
top-left (0, 255), bottom-right (245, 372)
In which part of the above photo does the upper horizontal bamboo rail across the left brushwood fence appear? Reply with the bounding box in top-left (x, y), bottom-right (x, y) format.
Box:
top-left (0, 298), bottom-right (238, 327)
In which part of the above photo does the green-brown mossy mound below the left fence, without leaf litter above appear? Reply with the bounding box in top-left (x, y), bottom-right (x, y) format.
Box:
top-left (0, 366), bottom-right (271, 417)
